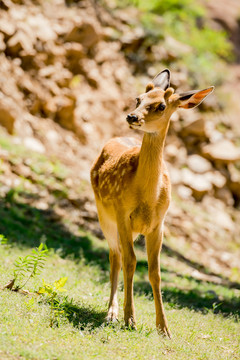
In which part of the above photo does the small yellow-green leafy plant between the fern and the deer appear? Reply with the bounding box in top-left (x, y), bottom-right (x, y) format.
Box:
top-left (37, 277), bottom-right (68, 327)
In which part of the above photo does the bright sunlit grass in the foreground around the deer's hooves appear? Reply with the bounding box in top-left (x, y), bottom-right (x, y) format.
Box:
top-left (0, 238), bottom-right (240, 360)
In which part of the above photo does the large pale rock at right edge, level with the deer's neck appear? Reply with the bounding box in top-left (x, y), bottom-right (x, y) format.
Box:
top-left (202, 139), bottom-right (240, 163)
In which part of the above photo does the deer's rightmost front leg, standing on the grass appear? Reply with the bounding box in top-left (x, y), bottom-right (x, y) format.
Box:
top-left (146, 228), bottom-right (171, 338)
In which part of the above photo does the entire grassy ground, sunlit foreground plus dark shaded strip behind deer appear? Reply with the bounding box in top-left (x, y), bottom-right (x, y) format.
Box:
top-left (0, 130), bottom-right (240, 360)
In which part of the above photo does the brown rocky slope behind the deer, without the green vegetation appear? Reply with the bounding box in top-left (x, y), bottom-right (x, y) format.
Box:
top-left (0, 0), bottom-right (240, 280)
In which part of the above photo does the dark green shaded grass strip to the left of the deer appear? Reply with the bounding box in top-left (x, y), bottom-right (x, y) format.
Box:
top-left (0, 199), bottom-right (109, 271)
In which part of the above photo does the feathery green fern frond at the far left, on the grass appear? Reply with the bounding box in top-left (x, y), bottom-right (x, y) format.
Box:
top-left (13, 243), bottom-right (48, 290)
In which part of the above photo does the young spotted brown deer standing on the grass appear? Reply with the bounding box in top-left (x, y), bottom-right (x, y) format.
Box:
top-left (91, 69), bottom-right (214, 338)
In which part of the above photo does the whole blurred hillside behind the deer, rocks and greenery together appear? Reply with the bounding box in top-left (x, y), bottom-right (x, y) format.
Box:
top-left (0, 0), bottom-right (240, 284)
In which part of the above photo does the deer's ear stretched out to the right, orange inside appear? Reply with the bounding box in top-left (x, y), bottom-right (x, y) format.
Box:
top-left (178, 86), bottom-right (214, 109)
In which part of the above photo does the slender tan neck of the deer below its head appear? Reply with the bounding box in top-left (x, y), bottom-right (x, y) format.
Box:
top-left (136, 126), bottom-right (168, 202)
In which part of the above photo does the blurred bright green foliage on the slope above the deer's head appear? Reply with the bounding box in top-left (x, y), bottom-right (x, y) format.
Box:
top-left (109, 0), bottom-right (234, 87)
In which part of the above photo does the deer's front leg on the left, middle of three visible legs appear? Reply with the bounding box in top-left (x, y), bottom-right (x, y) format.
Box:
top-left (118, 216), bottom-right (136, 328)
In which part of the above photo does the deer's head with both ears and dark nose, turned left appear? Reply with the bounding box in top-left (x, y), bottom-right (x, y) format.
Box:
top-left (127, 69), bottom-right (214, 133)
